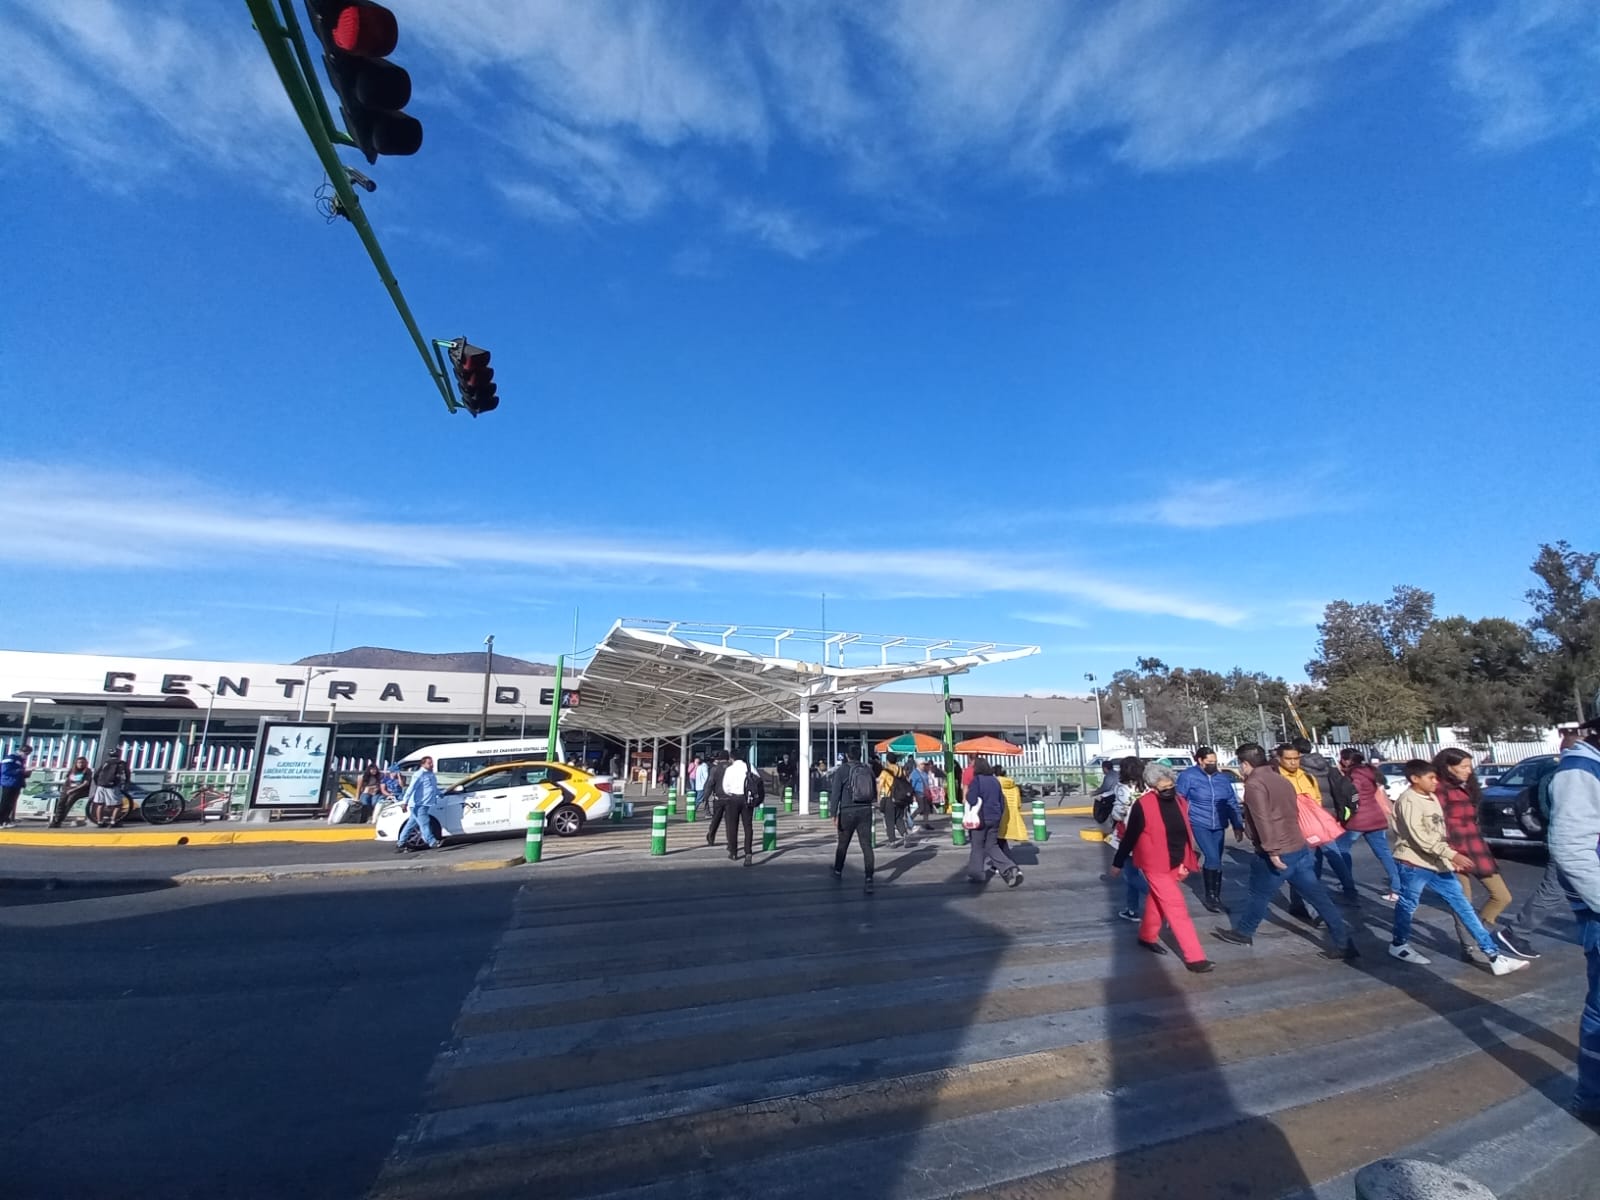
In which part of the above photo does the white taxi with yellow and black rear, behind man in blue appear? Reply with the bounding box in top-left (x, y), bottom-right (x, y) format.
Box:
top-left (374, 760), bottom-right (611, 842)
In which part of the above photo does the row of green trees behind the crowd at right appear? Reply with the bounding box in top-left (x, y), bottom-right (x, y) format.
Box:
top-left (1104, 541), bottom-right (1600, 744)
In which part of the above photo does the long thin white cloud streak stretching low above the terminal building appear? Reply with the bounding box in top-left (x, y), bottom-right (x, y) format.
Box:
top-left (0, 464), bottom-right (1245, 624)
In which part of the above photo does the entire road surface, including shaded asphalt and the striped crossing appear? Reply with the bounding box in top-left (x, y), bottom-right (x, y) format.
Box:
top-left (0, 822), bottom-right (1600, 1200)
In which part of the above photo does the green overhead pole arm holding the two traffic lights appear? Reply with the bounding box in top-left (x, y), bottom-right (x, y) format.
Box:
top-left (245, 0), bottom-right (459, 413)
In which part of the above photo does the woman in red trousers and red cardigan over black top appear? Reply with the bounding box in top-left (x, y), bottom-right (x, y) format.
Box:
top-left (1110, 763), bottom-right (1211, 974)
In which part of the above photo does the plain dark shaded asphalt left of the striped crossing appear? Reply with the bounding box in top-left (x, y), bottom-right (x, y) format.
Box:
top-left (0, 872), bottom-right (517, 1200)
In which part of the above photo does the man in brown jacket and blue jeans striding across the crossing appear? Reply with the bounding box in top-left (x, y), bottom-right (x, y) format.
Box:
top-left (1213, 742), bottom-right (1360, 962)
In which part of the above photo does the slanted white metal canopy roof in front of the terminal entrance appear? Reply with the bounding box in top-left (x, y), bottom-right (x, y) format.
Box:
top-left (563, 619), bottom-right (1038, 738)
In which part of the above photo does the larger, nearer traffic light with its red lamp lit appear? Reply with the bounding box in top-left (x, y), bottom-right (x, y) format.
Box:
top-left (306, 0), bottom-right (422, 163)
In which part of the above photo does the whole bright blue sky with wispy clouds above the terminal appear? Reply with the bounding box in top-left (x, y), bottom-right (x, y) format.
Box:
top-left (0, 0), bottom-right (1600, 691)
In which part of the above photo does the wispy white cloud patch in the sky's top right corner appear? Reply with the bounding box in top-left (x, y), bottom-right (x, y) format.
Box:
top-left (1451, 0), bottom-right (1600, 150)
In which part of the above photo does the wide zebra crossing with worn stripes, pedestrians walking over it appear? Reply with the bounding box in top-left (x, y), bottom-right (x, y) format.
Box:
top-left (371, 830), bottom-right (1600, 1200)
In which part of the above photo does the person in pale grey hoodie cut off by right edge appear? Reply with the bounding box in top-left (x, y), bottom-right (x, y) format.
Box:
top-left (1546, 717), bottom-right (1600, 1125)
